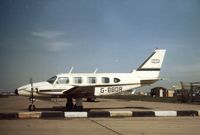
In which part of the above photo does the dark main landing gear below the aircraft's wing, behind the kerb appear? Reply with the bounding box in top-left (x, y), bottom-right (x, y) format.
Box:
top-left (66, 97), bottom-right (83, 111)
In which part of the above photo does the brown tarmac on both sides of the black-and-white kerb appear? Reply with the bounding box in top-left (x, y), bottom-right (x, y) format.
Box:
top-left (0, 96), bottom-right (200, 135)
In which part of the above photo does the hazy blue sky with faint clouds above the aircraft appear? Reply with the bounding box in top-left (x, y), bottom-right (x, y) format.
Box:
top-left (0, 0), bottom-right (200, 90)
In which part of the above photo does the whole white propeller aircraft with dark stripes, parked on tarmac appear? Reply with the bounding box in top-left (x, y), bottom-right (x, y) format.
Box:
top-left (15, 49), bottom-right (165, 111)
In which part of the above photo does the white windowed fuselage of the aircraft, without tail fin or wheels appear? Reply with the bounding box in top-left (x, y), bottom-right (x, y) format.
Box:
top-left (18, 73), bottom-right (154, 97)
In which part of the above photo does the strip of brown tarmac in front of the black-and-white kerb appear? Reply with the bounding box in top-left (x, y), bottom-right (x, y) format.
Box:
top-left (0, 117), bottom-right (200, 135)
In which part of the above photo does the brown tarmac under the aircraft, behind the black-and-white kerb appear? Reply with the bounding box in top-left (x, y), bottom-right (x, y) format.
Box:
top-left (0, 96), bottom-right (200, 112)
